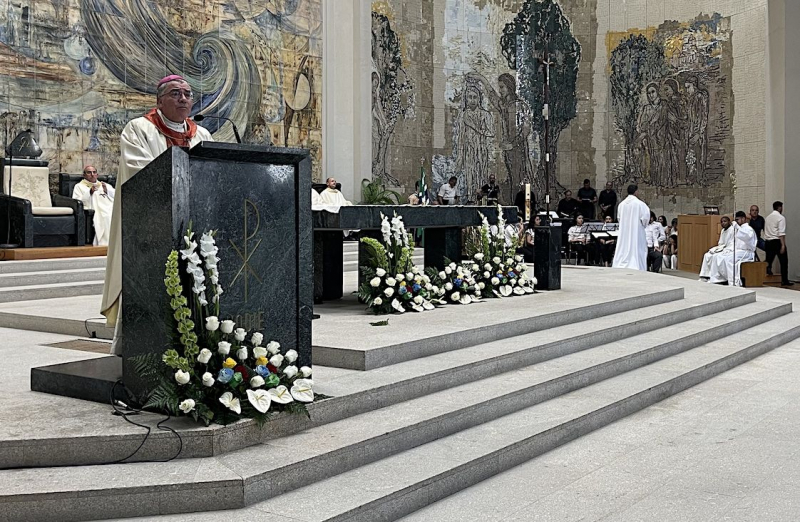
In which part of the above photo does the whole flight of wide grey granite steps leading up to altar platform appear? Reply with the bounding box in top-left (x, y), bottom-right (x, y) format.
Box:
top-left (0, 274), bottom-right (800, 522)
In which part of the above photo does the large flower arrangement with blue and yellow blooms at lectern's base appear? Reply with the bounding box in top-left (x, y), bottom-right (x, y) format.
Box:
top-left (134, 225), bottom-right (314, 425)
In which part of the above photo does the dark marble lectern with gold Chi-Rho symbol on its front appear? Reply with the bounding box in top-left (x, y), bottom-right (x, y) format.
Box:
top-left (33, 142), bottom-right (313, 401)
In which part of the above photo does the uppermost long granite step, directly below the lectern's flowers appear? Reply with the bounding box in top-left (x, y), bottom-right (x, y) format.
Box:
top-left (0, 285), bottom-right (748, 467)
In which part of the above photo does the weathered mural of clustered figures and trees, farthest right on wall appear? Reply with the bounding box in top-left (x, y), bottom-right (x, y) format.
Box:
top-left (609, 14), bottom-right (733, 193)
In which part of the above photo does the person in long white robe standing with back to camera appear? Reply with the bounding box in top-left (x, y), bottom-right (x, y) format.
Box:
top-left (611, 185), bottom-right (650, 271)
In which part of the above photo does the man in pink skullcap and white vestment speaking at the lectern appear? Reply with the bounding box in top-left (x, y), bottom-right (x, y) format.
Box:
top-left (100, 74), bottom-right (213, 355)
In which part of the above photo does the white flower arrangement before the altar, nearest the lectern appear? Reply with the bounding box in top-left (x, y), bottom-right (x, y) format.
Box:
top-left (358, 213), bottom-right (441, 314)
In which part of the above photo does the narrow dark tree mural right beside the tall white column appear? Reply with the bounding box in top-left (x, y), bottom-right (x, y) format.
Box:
top-left (371, 11), bottom-right (415, 186)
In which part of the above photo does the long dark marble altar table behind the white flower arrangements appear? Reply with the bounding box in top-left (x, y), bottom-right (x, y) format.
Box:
top-left (314, 205), bottom-right (519, 301)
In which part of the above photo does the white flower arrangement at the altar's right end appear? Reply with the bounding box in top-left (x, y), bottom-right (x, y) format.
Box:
top-left (465, 205), bottom-right (536, 297)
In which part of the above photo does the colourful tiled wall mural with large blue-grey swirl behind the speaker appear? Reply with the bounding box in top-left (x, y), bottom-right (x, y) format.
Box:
top-left (0, 0), bottom-right (322, 183)
